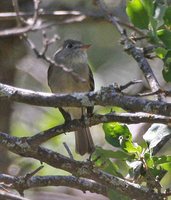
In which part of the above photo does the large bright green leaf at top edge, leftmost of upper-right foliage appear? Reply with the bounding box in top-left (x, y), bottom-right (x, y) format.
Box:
top-left (126, 0), bottom-right (150, 29)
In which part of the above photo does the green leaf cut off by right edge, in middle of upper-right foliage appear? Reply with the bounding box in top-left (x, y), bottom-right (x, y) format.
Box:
top-left (157, 29), bottom-right (171, 49)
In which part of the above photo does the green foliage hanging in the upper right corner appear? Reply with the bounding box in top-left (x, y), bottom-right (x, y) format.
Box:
top-left (126, 0), bottom-right (171, 82)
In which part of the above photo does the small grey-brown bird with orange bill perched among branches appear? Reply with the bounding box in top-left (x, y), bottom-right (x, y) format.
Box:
top-left (48, 39), bottom-right (94, 155)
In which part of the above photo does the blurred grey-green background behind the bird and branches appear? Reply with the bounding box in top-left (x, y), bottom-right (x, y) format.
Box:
top-left (0, 0), bottom-right (168, 200)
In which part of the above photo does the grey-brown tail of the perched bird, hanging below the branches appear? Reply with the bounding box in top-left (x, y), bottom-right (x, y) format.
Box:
top-left (75, 128), bottom-right (95, 155)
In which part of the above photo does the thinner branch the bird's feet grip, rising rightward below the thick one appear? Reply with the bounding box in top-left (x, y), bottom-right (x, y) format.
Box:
top-left (24, 113), bottom-right (171, 147)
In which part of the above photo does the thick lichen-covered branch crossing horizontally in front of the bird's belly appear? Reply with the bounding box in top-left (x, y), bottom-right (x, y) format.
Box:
top-left (0, 83), bottom-right (171, 116)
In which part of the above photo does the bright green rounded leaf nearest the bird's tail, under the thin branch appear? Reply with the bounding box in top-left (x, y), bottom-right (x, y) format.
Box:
top-left (103, 122), bottom-right (132, 147)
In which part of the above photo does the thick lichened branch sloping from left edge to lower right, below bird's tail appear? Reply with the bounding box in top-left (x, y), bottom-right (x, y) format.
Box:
top-left (0, 133), bottom-right (162, 200)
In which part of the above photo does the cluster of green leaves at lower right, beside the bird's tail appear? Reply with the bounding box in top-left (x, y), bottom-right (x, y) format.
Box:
top-left (93, 122), bottom-right (171, 199)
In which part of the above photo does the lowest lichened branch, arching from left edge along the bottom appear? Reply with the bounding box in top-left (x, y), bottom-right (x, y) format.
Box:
top-left (0, 174), bottom-right (107, 196)
